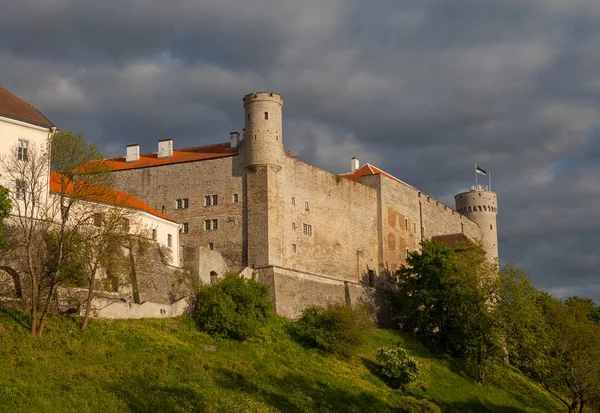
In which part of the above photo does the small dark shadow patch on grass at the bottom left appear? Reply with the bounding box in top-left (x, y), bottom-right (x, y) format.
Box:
top-left (108, 377), bottom-right (206, 413)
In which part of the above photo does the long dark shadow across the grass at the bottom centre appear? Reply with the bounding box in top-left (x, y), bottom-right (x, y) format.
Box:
top-left (216, 370), bottom-right (435, 413)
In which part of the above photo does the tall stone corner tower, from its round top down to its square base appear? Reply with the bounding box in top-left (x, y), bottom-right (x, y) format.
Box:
top-left (243, 92), bottom-right (286, 269)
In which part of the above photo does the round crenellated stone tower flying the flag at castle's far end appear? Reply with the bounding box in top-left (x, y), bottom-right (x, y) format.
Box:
top-left (454, 185), bottom-right (498, 260)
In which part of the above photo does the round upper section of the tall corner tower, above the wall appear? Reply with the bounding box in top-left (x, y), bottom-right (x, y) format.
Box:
top-left (244, 92), bottom-right (285, 170)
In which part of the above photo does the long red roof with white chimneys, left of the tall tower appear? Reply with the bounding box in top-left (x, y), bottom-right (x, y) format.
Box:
top-left (91, 143), bottom-right (238, 171)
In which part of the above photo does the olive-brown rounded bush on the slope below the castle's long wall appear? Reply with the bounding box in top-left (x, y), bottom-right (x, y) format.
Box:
top-left (296, 303), bottom-right (373, 357)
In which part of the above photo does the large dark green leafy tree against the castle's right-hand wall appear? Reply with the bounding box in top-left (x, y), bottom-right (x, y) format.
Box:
top-left (397, 241), bottom-right (502, 383)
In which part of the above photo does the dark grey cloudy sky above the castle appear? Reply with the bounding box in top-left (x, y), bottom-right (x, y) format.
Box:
top-left (0, 0), bottom-right (600, 303)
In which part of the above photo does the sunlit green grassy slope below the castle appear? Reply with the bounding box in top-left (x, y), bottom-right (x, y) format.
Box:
top-left (0, 309), bottom-right (564, 413)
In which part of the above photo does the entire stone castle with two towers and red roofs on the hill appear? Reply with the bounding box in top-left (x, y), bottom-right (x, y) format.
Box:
top-left (104, 92), bottom-right (498, 317)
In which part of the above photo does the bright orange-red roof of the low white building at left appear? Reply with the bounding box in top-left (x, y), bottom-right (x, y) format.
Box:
top-left (50, 172), bottom-right (177, 222)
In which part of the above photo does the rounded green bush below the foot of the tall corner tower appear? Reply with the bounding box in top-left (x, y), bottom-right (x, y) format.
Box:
top-left (192, 274), bottom-right (273, 341)
